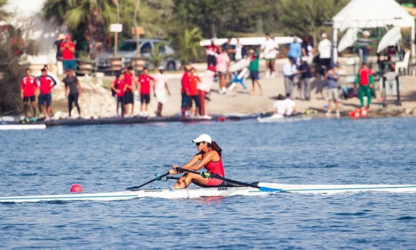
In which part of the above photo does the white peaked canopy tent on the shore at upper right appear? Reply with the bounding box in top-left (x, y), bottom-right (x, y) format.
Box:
top-left (332, 0), bottom-right (415, 60)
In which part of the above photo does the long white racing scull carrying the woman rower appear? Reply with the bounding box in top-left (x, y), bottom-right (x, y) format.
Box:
top-left (0, 182), bottom-right (416, 203)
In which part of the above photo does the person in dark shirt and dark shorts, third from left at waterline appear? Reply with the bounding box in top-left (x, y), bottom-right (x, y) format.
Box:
top-left (63, 69), bottom-right (82, 117)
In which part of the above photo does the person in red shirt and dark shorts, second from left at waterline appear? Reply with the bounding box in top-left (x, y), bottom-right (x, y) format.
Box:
top-left (36, 69), bottom-right (56, 121)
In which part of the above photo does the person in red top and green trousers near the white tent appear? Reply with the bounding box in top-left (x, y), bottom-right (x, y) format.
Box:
top-left (356, 63), bottom-right (374, 108)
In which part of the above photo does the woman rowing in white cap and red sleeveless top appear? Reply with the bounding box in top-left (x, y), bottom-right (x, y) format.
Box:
top-left (169, 134), bottom-right (224, 188)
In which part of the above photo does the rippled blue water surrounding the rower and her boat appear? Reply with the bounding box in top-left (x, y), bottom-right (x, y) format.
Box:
top-left (0, 119), bottom-right (416, 249)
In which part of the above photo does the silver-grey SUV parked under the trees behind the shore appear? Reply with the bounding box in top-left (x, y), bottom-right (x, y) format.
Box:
top-left (96, 38), bottom-right (181, 71)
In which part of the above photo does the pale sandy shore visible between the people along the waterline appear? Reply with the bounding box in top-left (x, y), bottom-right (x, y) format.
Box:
top-left (53, 60), bottom-right (416, 118)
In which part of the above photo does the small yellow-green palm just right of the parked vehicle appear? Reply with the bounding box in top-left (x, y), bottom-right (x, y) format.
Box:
top-left (177, 27), bottom-right (203, 65)
